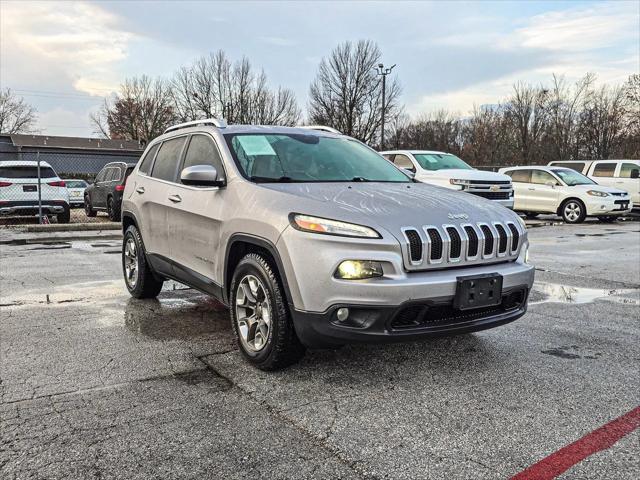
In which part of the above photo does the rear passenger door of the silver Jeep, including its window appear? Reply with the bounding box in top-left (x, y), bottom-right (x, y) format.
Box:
top-left (138, 135), bottom-right (187, 266)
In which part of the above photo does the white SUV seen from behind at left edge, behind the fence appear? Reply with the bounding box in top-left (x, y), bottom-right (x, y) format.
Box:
top-left (0, 161), bottom-right (70, 223)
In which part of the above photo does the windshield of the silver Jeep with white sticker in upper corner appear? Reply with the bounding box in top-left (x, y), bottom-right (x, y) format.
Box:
top-left (225, 134), bottom-right (411, 183)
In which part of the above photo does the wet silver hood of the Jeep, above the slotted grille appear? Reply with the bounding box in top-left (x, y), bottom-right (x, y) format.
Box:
top-left (261, 182), bottom-right (518, 235)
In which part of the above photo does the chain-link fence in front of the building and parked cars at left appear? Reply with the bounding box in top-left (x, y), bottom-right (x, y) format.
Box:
top-left (0, 151), bottom-right (141, 226)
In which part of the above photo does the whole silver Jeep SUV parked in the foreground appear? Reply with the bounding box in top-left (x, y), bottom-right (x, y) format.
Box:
top-left (122, 119), bottom-right (534, 370)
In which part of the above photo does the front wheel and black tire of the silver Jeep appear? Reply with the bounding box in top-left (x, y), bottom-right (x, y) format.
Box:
top-left (229, 253), bottom-right (305, 371)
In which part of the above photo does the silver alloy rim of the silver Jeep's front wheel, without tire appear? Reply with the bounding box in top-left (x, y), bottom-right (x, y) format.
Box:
top-left (235, 275), bottom-right (272, 352)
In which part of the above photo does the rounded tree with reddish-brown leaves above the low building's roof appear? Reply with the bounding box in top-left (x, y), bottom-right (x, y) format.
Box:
top-left (91, 75), bottom-right (175, 141)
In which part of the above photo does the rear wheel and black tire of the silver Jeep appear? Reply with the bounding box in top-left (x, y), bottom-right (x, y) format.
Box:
top-left (122, 225), bottom-right (164, 298)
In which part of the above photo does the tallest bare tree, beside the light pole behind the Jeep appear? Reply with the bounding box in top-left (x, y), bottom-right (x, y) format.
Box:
top-left (309, 40), bottom-right (401, 144)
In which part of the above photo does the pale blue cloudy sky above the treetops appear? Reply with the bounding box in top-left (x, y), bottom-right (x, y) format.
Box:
top-left (0, 0), bottom-right (640, 136)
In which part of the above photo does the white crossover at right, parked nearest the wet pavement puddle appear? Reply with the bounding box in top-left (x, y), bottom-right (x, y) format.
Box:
top-left (499, 166), bottom-right (632, 223)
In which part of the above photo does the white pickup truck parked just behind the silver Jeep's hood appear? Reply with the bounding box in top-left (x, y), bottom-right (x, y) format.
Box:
top-left (380, 150), bottom-right (513, 209)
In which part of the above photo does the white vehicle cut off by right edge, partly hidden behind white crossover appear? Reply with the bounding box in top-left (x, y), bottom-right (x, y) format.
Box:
top-left (549, 160), bottom-right (640, 209)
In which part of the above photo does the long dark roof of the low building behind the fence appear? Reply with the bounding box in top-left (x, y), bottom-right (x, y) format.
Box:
top-left (3, 134), bottom-right (144, 152)
